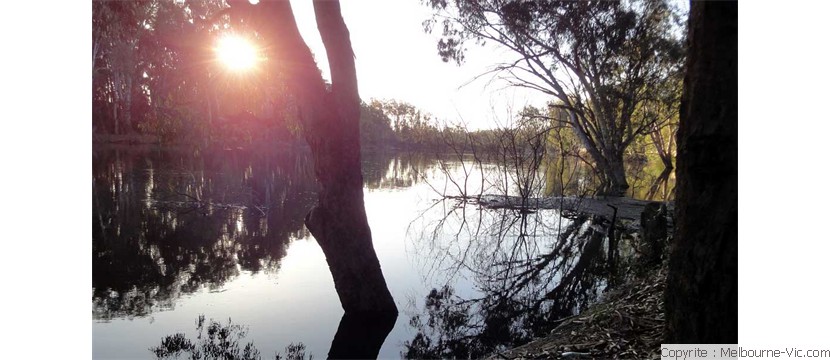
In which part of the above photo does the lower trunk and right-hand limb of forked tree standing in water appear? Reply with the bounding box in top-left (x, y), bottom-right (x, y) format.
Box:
top-left (306, 0), bottom-right (398, 313)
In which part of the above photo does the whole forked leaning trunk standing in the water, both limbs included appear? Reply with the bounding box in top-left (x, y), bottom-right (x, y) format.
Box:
top-left (228, 0), bottom-right (397, 314)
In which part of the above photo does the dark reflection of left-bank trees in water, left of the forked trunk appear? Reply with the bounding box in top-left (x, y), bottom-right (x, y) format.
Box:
top-left (92, 151), bottom-right (315, 320)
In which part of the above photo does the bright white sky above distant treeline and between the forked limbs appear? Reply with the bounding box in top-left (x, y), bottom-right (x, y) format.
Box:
top-left (292, 0), bottom-right (547, 129)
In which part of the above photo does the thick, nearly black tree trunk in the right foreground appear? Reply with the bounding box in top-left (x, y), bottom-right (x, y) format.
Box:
top-left (665, 1), bottom-right (738, 344)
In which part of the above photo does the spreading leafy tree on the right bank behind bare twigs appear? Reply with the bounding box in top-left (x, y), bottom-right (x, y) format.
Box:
top-left (424, 0), bottom-right (683, 195)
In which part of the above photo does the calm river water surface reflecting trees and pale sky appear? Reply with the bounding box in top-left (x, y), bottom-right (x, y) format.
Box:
top-left (92, 148), bottom-right (656, 359)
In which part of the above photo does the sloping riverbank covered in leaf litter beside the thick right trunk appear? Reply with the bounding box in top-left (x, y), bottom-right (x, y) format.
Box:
top-left (490, 263), bottom-right (667, 359)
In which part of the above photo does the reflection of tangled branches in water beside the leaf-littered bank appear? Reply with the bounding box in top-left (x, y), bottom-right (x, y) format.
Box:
top-left (401, 199), bottom-right (629, 358)
